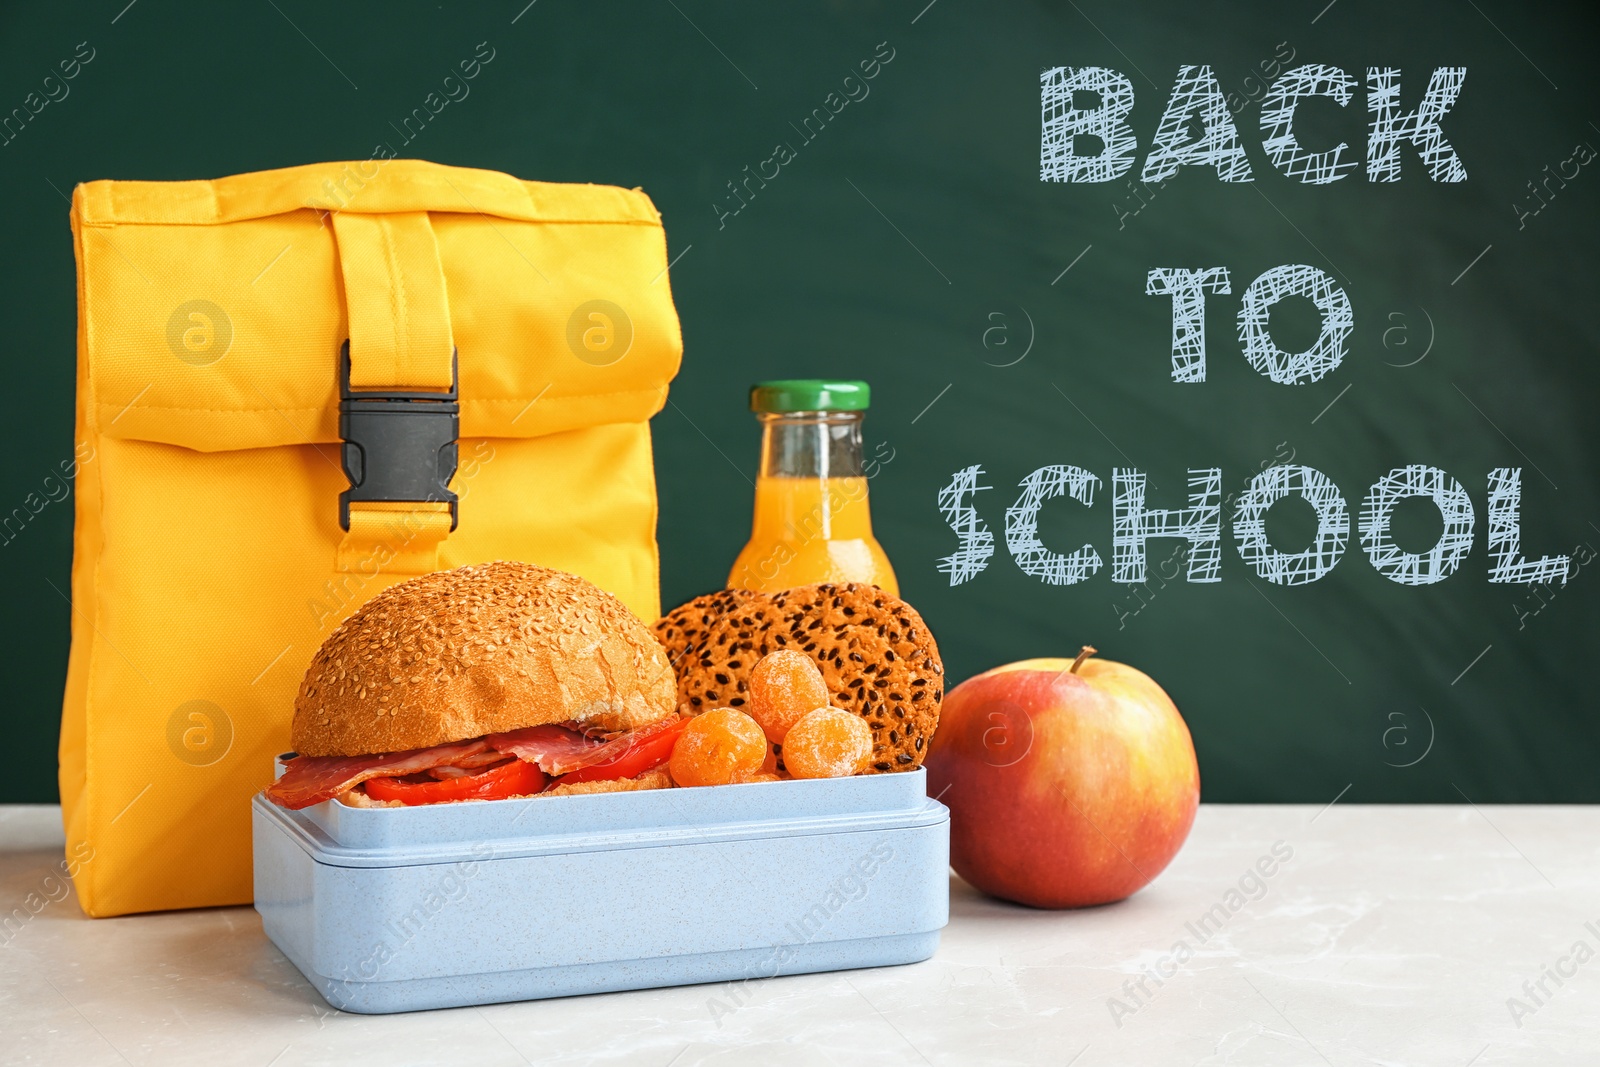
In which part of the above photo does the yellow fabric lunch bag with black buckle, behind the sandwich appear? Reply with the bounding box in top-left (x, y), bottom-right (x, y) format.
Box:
top-left (61, 158), bottom-right (683, 915)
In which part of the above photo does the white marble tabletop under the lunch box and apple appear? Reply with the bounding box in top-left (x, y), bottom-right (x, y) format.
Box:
top-left (0, 803), bottom-right (1600, 1067)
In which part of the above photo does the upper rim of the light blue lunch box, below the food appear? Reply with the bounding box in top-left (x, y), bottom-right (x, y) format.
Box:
top-left (253, 769), bottom-right (949, 867)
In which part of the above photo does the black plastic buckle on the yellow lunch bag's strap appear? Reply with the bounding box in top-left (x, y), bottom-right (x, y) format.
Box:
top-left (339, 341), bottom-right (461, 531)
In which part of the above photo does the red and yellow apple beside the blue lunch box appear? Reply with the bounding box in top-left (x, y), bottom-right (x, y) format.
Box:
top-left (928, 648), bottom-right (1200, 907)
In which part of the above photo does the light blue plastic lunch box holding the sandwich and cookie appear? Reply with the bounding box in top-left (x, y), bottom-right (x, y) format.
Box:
top-left (251, 769), bottom-right (950, 1013)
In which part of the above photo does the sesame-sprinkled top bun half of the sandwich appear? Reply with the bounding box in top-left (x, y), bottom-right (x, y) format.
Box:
top-left (291, 561), bottom-right (677, 755)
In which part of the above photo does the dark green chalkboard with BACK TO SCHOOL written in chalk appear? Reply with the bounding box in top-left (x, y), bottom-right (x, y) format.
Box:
top-left (0, 0), bottom-right (1600, 803)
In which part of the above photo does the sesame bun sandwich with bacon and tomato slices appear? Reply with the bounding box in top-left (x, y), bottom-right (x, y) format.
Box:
top-left (266, 561), bottom-right (685, 809)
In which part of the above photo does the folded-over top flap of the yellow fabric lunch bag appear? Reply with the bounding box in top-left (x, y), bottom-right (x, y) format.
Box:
top-left (72, 160), bottom-right (683, 451)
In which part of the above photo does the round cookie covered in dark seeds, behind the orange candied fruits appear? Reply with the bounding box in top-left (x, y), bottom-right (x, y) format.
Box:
top-left (654, 582), bottom-right (944, 773)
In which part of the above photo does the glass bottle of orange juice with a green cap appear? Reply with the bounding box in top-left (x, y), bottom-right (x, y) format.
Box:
top-left (728, 379), bottom-right (899, 593)
